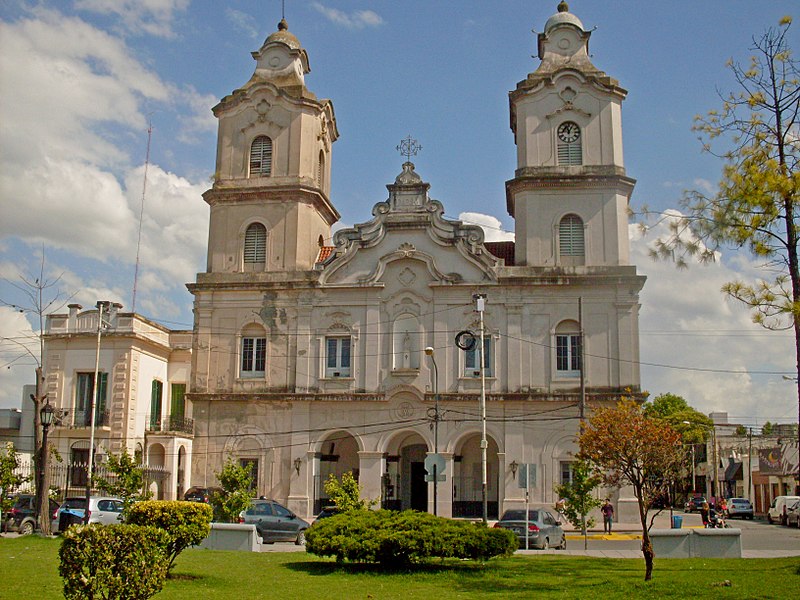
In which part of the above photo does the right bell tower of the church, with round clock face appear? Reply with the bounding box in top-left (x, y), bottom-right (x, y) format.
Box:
top-left (506, 2), bottom-right (635, 268)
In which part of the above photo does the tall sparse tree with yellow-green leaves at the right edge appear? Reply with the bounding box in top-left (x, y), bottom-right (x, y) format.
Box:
top-left (640, 17), bottom-right (800, 477)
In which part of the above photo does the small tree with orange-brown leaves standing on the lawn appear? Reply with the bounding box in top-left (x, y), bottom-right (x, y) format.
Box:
top-left (578, 400), bottom-right (686, 581)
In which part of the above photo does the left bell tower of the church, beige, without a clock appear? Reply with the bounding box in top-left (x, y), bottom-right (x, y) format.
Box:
top-left (203, 19), bottom-right (339, 273)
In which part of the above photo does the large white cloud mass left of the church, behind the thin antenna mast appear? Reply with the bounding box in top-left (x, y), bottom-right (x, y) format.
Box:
top-left (0, 9), bottom-right (209, 314)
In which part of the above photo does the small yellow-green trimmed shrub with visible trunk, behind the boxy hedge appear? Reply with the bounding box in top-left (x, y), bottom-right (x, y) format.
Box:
top-left (127, 500), bottom-right (213, 569)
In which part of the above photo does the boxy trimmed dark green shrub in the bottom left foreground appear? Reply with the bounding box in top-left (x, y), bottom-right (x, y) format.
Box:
top-left (58, 524), bottom-right (169, 600)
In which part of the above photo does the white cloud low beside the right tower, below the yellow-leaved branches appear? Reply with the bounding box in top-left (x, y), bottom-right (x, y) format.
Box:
top-left (630, 218), bottom-right (797, 424)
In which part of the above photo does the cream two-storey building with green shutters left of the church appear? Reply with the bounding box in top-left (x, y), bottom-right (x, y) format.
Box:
top-left (44, 304), bottom-right (193, 499)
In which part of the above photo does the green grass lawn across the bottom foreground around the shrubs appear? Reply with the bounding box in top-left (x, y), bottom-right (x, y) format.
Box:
top-left (0, 536), bottom-right (800, 600)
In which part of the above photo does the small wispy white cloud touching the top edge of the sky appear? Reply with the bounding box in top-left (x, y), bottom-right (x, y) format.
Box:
top-left (75, 0), bottom-right (190, 37)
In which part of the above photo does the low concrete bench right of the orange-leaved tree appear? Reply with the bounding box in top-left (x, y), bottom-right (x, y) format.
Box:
top-left (650, 529), bottom-right (742, 558)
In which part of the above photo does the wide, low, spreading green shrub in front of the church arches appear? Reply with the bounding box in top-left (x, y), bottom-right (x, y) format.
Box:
top-left (306, 510), bottom-right (517, 565)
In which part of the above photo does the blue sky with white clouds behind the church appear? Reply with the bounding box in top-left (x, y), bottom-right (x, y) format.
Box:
top-left (0, 0), bottom-right (800, 425)
